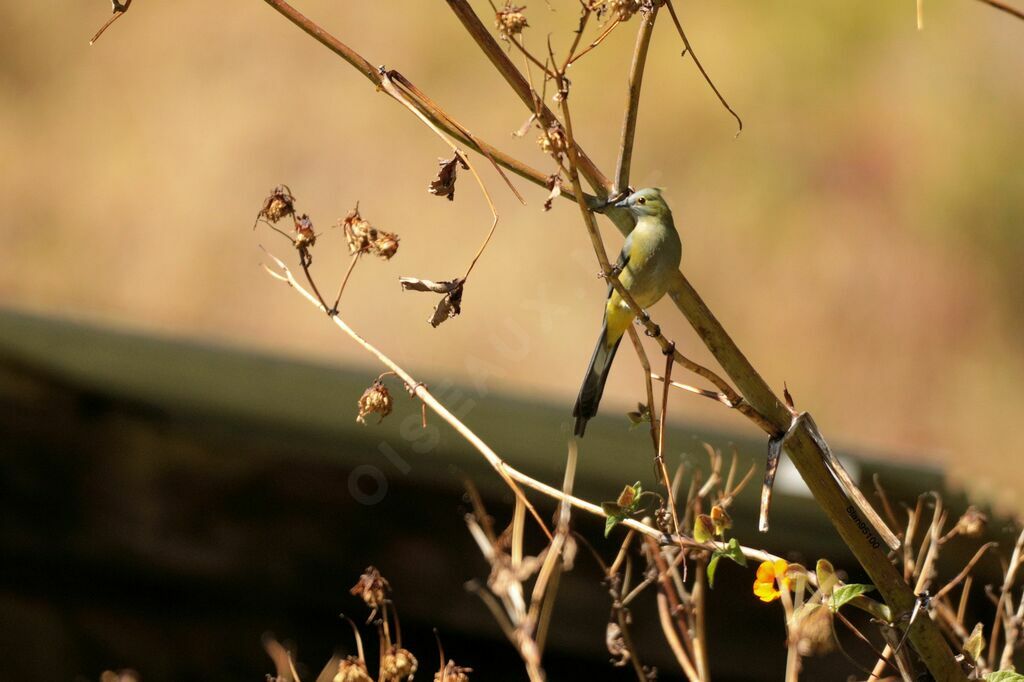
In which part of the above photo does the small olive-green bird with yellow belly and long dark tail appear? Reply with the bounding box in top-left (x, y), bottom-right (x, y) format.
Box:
top-left (572, 188), bottom-right (683, 437)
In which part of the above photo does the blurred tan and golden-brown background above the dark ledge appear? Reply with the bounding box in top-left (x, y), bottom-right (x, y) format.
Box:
top-left (6, 5), bottom-right (1024, 509)
